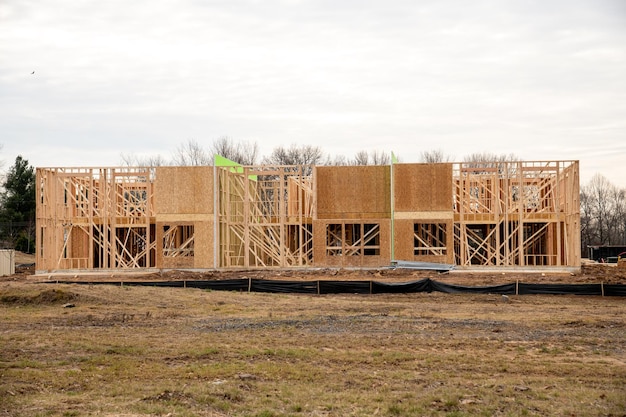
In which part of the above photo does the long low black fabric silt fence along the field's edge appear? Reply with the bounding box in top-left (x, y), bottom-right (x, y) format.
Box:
top-left (50, 278), bottom-right (626, 297)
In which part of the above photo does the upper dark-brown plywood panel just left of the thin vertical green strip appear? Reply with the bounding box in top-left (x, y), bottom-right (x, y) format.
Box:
top-left (315, 166), bottom-right (391, 219)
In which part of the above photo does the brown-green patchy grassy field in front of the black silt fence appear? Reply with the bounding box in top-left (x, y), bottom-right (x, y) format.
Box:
top-left (0, 282), bottom-right (626, 417)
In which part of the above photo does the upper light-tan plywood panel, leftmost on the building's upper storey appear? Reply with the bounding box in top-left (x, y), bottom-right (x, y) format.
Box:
top-left (154, 166), bottom-right (214, 216)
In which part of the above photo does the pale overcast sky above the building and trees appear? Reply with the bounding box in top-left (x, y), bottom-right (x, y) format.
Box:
top-left (0, 0), bottom-right (626, 187)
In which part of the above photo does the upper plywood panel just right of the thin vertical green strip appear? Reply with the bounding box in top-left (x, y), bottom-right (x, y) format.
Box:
top-left (393, 163), bottom-right (452, 212)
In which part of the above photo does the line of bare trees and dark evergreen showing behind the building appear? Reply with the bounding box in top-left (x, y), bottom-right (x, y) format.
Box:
top-left (0, 137), bottom-right (626, 257)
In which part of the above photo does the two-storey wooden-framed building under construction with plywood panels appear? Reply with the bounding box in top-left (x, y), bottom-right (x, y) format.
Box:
top-left (36, 161), bottom-right (580, 273)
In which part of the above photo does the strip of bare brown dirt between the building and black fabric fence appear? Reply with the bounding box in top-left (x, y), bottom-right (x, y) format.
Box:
top-left (0, 252), bottom-right (626, 286)
